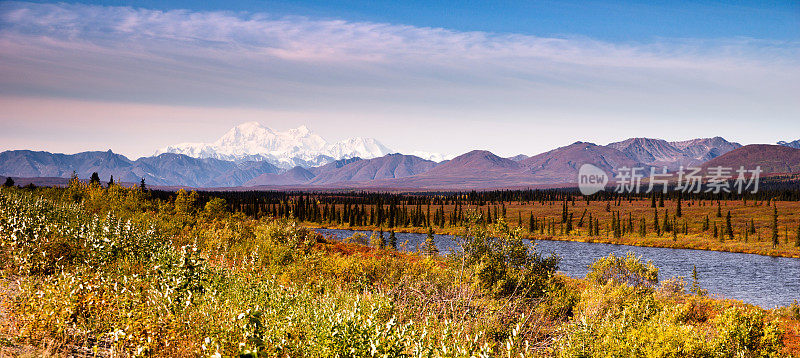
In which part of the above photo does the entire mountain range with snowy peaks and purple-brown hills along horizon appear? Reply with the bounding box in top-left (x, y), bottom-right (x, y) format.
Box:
top-left (0, 123), bottom-right (800, 190)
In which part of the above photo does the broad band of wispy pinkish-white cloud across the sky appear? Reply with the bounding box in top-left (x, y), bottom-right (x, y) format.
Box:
top-left (0, 2), bottom-right (800, 156)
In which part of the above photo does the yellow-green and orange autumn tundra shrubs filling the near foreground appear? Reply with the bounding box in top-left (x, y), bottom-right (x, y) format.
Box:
top-left (0, 180), bottom-right (800, 357)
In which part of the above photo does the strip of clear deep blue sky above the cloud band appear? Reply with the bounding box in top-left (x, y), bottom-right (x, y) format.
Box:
top-left (17, 0), bottom-right (800, 41)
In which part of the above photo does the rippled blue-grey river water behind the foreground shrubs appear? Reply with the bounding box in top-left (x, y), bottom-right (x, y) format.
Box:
top-left (315, 229), bottom-right (800, 308)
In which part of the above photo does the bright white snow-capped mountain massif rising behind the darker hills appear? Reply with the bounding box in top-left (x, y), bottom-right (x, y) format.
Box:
top-left (155, 122), bottom-right (392, 169)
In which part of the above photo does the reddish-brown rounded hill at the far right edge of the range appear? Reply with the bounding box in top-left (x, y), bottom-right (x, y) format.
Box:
top-left (702, 144), bottom-right (800, 174)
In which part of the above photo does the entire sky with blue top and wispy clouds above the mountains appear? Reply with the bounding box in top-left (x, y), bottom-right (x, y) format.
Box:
top-left (0, 0), bottom-right (800, 158)
